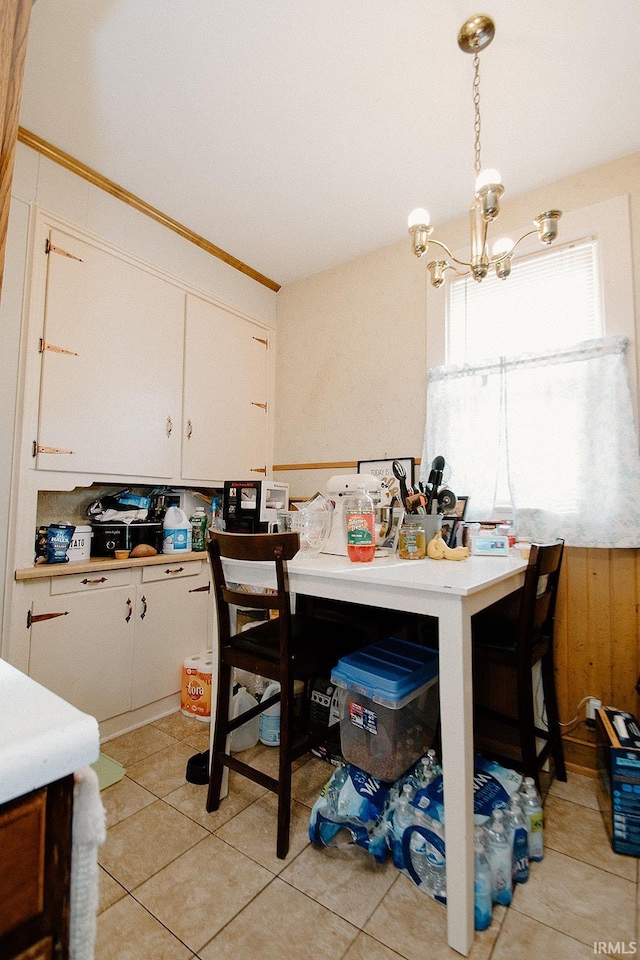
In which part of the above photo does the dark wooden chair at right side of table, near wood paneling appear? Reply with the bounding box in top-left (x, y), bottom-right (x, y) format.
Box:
top-left (472, 540), bottom-right (567, 790)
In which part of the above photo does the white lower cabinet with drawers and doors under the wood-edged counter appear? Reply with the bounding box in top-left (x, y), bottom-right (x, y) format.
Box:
top-left (25, 559), bottom-right (212, 721)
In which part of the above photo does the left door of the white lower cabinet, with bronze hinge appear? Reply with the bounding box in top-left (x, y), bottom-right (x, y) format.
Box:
top-left (25, 585), bottom-right (135, 721)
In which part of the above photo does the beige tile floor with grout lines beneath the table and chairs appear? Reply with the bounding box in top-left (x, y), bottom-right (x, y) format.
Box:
top-left (95, 713), bottom-right (640, 960)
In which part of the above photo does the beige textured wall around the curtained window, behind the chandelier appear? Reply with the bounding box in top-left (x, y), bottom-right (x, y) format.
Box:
top-left (274, 153), bottom-right (640, 496)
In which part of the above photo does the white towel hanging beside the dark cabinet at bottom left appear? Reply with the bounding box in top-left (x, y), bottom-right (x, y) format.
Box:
top-left (69, 767), bottom-right (107, 960)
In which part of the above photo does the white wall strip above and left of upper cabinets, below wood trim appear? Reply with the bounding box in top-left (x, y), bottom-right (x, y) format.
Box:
top-left (0, 143), bottom-right (276, 636)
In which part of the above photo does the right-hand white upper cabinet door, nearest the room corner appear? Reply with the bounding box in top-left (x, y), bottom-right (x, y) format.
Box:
top-left (182, 295), bottom-right (268, 482)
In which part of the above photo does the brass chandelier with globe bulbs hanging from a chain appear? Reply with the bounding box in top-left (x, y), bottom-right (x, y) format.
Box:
top-left (407, 15), bottom-right (562, 287)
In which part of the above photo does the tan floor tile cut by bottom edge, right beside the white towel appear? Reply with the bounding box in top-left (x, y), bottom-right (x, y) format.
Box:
top-left (95, 897), bottom-right (193, 960)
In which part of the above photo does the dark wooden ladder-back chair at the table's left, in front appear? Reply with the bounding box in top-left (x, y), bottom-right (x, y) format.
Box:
top-left (207, 532), bottom-right (363, 859)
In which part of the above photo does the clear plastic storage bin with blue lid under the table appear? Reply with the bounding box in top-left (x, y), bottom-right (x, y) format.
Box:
top-left (331, 637), bottom-right (439, 780)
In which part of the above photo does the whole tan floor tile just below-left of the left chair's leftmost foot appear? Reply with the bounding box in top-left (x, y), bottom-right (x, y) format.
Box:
top-left (98, 800), bottom-right (207, 890)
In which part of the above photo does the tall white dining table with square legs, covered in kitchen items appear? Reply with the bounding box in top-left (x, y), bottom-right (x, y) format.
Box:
top-left (211, 551), bottom-right (527, 956)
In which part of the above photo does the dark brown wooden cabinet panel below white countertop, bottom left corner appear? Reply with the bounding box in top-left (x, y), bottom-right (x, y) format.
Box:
top-left (0, 790), bottom-right (47, 936)
